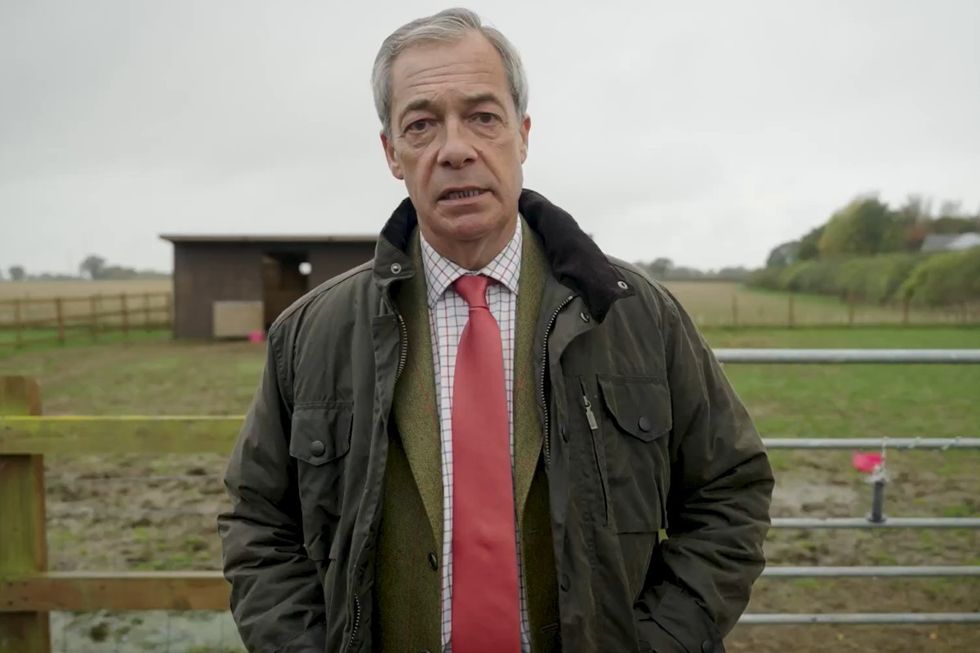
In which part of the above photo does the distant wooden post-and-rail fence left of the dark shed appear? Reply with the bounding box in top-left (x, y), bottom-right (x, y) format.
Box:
top-left (0, 292), bottom-right (173, 347)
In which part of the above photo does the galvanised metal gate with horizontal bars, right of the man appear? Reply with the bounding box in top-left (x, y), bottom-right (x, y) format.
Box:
top-left (714, 349), bottom-right (980, 626)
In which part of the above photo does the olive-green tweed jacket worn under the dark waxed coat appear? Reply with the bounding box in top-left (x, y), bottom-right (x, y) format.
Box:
top-left (373, 220), bottom-right (559, 653)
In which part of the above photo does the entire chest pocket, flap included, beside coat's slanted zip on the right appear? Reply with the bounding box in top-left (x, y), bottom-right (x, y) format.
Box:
top-left (598, 375), bottom-right (673, 533)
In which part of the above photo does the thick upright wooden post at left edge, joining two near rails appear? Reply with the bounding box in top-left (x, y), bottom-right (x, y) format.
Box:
top-left (0, 376), bottom-right (51, 653)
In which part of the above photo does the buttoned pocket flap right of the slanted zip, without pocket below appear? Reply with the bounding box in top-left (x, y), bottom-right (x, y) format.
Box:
top-left (598, 375), bottom-right (673, 442)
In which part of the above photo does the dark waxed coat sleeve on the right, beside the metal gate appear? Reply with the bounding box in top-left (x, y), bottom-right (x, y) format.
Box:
top-left (635, 291), bottom-right (773, 653)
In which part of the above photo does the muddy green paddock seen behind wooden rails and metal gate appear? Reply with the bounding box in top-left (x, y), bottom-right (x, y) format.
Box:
top-left (0, 324), bottom-right (980, 653)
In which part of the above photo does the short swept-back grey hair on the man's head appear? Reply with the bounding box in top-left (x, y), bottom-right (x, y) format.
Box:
top-left (371, 9), bottom-right (527, 135)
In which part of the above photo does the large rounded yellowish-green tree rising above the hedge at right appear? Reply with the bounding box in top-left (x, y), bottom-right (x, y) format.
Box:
top-left (819, 197), bottom-right (903, 258)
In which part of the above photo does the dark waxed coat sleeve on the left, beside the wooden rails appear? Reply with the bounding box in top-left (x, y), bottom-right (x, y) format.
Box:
top-left (218, 329), bottom-right (326, 653)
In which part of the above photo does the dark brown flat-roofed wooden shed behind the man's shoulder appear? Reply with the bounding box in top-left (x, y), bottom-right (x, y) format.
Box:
top-left (160, 234), bottom-right (377, 338)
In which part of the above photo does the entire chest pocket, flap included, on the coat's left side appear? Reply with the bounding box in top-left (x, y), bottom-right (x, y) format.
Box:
top-left (289, 404), bottom-right (353, 560)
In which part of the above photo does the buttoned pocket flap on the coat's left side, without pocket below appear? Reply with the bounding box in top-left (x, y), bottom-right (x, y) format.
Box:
top-left (289, 405), bottom-right (353, 466)
